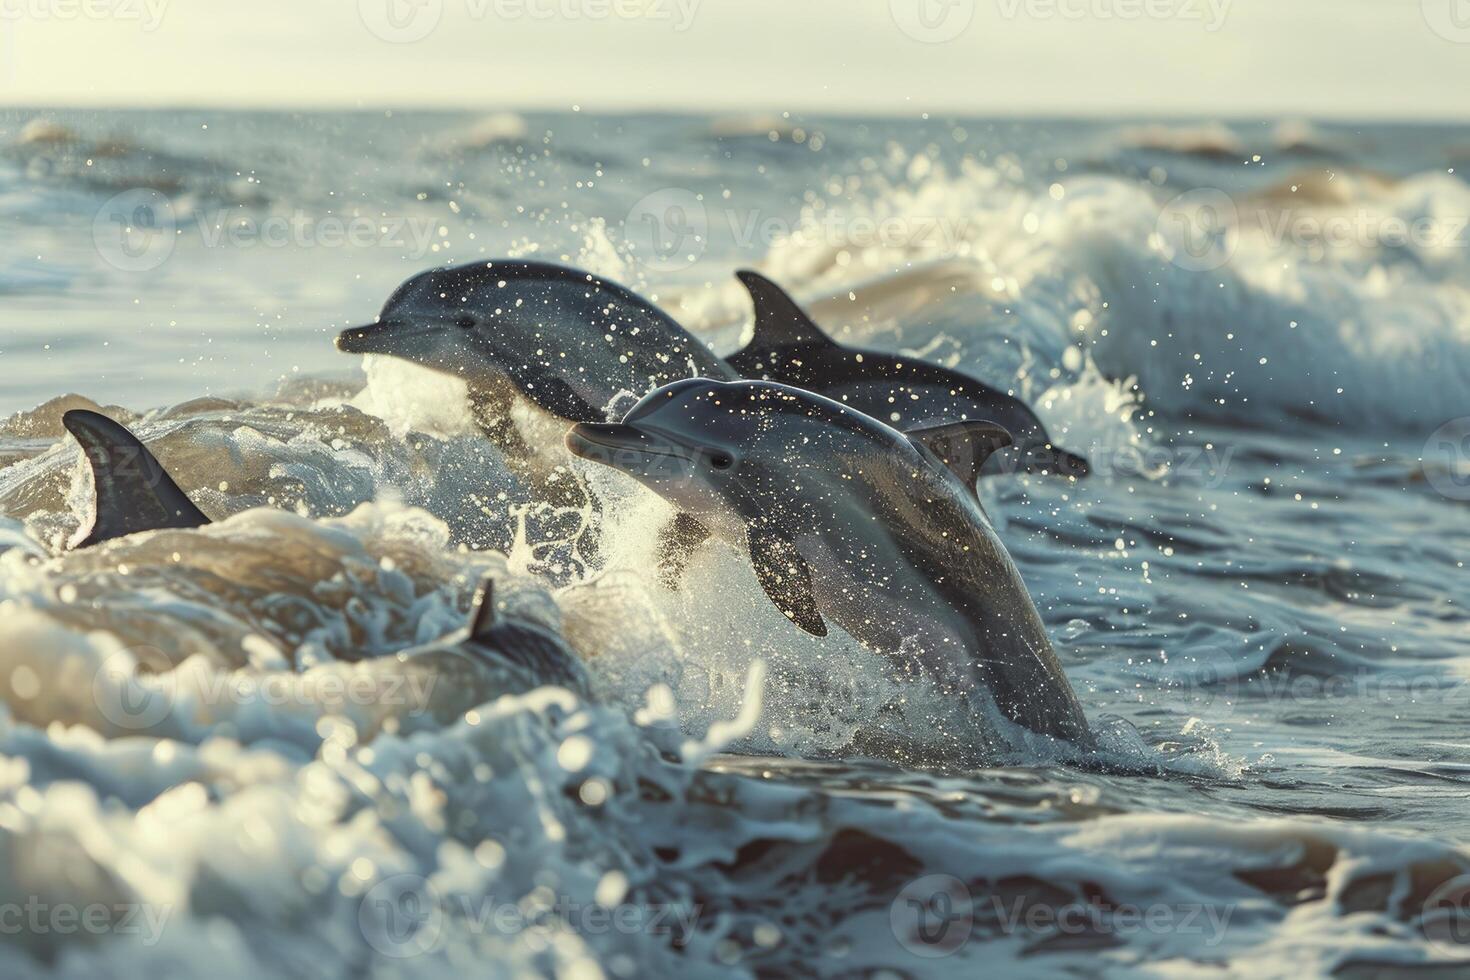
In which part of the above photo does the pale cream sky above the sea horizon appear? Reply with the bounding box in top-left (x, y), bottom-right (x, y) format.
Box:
top-left (0, 0), bottom-right (1470, 119)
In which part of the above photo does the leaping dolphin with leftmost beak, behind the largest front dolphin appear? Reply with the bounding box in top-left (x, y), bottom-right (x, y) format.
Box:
top-left (337, 259), bottom-right (736, 422)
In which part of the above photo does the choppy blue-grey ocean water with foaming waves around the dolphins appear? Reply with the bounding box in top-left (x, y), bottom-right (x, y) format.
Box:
top-left (0, 109), bottom-right (1470, 977)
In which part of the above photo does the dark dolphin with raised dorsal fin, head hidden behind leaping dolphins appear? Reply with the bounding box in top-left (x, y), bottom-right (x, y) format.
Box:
top-left (725, 269), bottom-right (1089, 476)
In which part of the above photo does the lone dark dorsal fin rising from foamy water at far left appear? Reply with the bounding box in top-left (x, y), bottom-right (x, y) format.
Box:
top-left (62, 408), bottom-right (209, 548)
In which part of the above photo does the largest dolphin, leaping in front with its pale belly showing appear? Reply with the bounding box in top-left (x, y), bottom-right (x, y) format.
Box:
top-left (566, 379), bottom-right (1088, 741)
